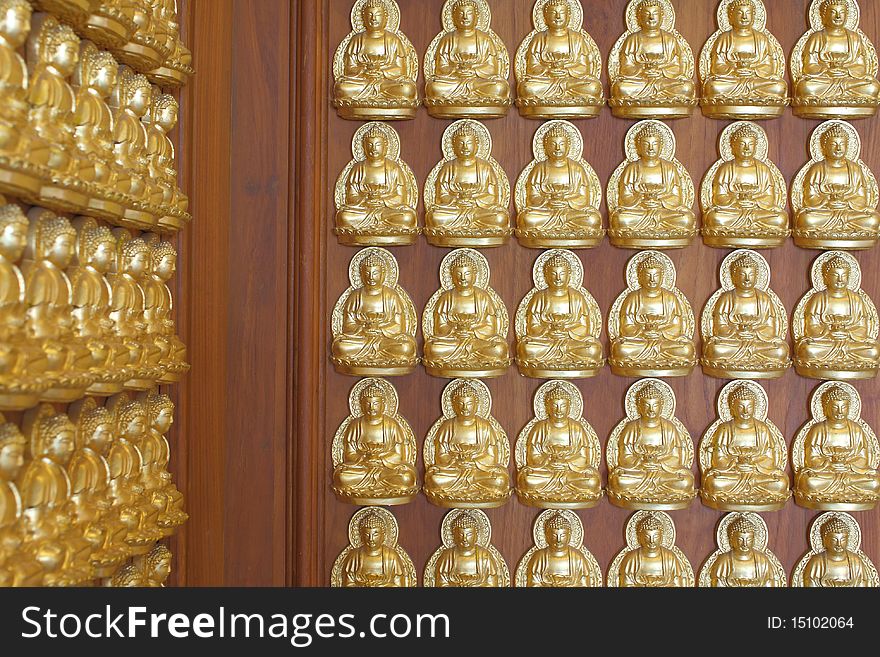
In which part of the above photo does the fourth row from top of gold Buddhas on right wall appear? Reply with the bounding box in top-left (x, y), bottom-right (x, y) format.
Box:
top-left (331, 378), bottom-right (880, 511)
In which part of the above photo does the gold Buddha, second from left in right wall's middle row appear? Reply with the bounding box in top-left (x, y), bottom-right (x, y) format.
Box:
top-left (422, 249), bottom-right (510, 378)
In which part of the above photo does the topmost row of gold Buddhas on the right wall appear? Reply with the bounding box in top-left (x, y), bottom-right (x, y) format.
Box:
top-left (333, 0), bottom-right (880, 120)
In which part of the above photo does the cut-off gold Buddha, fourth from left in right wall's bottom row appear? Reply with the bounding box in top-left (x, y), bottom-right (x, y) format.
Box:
top-left (608, 511), bottom-right (694, 588)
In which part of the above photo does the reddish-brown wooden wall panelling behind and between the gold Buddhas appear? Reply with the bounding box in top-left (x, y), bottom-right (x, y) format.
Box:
top-left (176, 0), bottom-right (880, 586)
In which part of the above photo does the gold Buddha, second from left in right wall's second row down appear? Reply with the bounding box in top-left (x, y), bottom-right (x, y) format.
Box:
top-left (424, 119), bottom-right (513, 247)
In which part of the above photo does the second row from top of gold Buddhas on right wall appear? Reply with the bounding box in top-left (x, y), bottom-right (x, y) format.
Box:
top-left (334, 119), bottom-right (880, 250)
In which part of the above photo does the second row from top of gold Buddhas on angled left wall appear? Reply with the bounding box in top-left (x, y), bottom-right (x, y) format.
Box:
top-left (0, 0), bottom-right (191, 231)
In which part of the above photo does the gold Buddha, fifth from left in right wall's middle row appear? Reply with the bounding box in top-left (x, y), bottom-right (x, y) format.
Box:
top-left (700, 249), bottom-right (791, 379)
